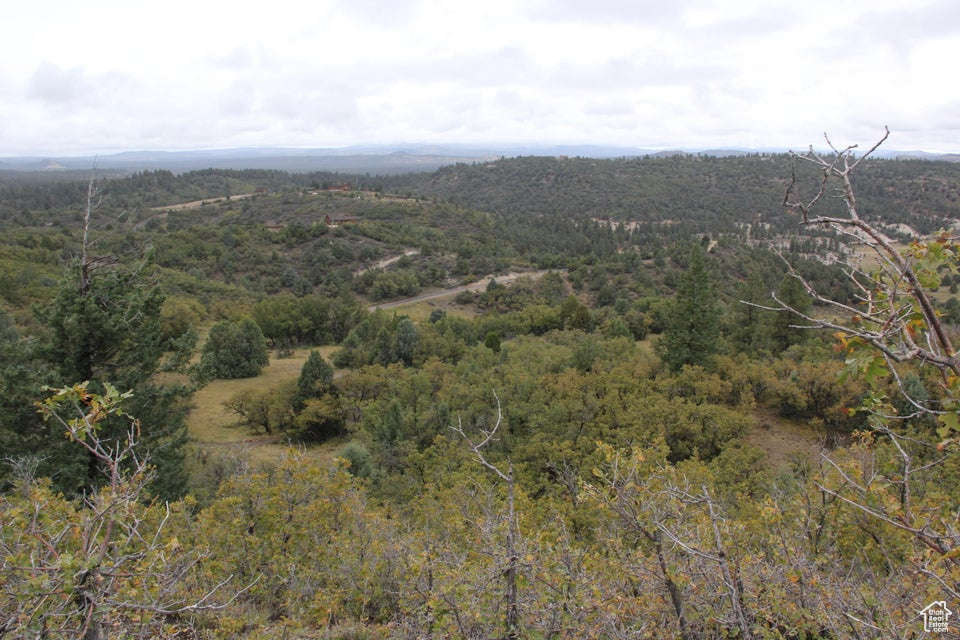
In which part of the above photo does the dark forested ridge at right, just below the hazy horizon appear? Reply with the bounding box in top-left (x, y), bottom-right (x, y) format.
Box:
top-left (393, 154), bottom-right (960, 233)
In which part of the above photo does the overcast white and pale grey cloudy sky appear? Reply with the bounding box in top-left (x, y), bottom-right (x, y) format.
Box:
top-left (0, 0), bottom-right (960, 157)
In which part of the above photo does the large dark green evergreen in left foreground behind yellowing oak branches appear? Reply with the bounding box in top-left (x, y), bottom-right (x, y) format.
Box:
top-left (41, 255), bottom-right (192, 498)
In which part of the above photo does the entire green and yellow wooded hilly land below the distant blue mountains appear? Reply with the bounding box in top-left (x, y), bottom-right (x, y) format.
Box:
top-left (0, 148), bottom-right (960, 640)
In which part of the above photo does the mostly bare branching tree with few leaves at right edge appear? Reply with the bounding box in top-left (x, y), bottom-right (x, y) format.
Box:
top-left (764, 128), bottom-right (960, 597)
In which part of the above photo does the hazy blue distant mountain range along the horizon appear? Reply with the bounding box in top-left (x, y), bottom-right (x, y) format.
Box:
top-left (0, 144), bottom-right (960, 174)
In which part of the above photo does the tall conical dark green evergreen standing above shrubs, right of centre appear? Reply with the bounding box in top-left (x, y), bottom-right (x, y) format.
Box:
top-left (657, 245), bottom-right (720, 371)
